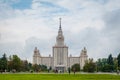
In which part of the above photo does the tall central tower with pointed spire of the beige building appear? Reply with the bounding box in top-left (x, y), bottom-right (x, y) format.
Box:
top-left (53, 18), bottom-right (68, 71)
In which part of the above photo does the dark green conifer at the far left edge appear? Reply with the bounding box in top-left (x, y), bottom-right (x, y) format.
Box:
top-left (0, 53), bottom-right (7, 71)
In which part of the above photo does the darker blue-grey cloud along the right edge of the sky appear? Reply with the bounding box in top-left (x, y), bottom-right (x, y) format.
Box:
top-left (103, 9), bottom-right (120, 55)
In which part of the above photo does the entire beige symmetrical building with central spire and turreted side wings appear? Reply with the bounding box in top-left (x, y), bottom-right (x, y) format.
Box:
top-left (33, 19), bottom-right (88, 71)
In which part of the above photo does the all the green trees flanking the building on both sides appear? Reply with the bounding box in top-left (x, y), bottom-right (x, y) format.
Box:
top-left (0, 53), bottom-right (120, 72)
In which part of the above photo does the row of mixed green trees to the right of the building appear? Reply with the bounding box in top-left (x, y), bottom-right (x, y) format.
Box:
top-left (83, 53), bottom-right (120, 72)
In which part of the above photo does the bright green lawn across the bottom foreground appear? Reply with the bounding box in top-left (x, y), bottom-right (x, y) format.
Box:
top-left (0, 74), bottom-right (120, 80)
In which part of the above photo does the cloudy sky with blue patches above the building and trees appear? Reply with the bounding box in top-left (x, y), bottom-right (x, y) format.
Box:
top-left (0, 0), bottom-right (120, 62)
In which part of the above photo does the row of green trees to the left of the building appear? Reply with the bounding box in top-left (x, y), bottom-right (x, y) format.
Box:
top-left (0, 54), bottom-right (47, 72)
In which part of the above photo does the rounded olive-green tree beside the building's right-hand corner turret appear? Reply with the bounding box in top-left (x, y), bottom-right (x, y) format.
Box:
top-left (83, 59), bottom-right (96, 72)
